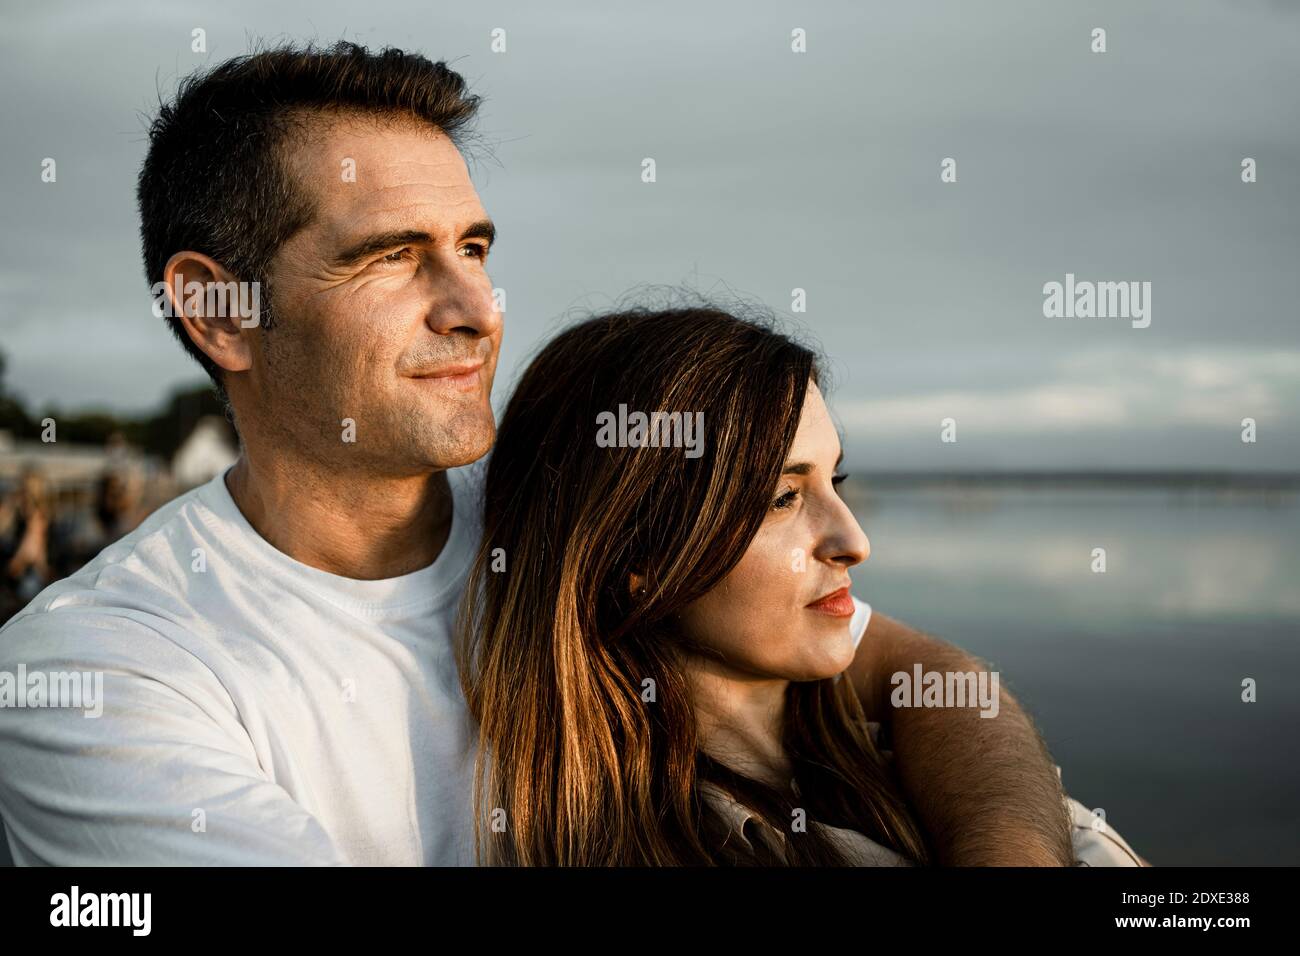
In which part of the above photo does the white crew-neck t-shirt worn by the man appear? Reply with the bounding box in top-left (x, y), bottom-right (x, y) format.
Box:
top-left (0, 468), bottom-right (480, 865)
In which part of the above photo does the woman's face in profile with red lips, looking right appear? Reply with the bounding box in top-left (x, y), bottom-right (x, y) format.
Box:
top-left (681, 382), bottom-right (871, 680)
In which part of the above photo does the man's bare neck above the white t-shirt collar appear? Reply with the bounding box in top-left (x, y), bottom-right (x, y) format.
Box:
top-left (225, 453), bottom-right (452, 580)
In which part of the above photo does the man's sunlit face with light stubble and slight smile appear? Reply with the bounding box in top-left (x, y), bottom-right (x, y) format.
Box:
top-left (245, 117), bottom-right (502, 475)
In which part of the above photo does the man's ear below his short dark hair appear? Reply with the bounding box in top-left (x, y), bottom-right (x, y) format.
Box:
top-left (155, 250), bottom-right (261, 372)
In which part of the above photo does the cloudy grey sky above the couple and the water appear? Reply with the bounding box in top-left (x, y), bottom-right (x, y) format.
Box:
top-left (0, 0), bottom-right (1300, 471)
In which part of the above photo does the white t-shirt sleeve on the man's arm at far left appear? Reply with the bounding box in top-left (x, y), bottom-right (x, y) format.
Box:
top-left (0, 611), bottom-right (347, 866)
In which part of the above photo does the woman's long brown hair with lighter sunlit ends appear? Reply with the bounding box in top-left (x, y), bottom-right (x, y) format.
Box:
top-left (458, 299), bottom-right (930, 865)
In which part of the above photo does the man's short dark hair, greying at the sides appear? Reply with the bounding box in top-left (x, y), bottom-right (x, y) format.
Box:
top-left (137, 43), bottom-right (480, 398)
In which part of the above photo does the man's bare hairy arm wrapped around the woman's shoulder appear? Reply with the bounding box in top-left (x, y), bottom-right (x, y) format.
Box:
top-left (848, 611), bottom-right (1074, 866)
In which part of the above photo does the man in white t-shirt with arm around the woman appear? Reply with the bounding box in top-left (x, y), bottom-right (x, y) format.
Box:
top-left (0, 44), bottom-right (1071, 865)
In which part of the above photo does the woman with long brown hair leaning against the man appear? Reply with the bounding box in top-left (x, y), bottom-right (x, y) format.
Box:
top-left (459, 300), bottom-right (1144, 865)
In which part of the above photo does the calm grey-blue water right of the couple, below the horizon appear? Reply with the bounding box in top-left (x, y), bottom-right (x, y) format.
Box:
top-left (844, 479), bottom-right (1300, 866)
